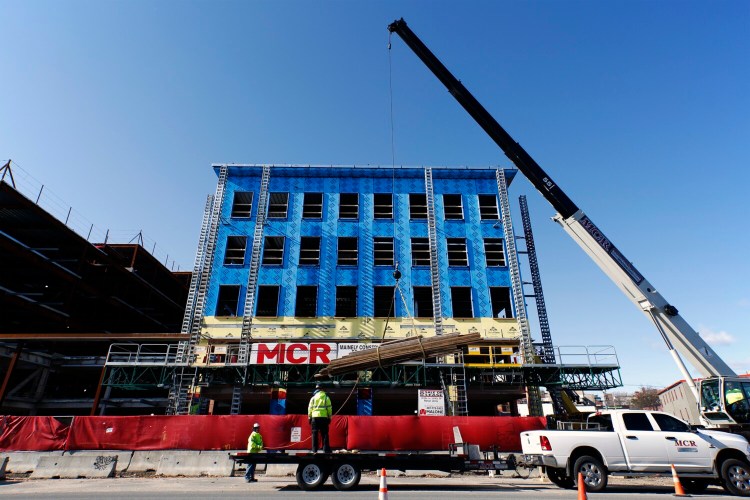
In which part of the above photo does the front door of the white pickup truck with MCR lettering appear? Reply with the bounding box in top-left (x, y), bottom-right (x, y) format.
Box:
top-left (651, 413), bottom-right (717, 472)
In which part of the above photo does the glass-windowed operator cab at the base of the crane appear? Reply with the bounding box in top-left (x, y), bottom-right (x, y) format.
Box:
top-left (700, 377), bottom-right (750, 425)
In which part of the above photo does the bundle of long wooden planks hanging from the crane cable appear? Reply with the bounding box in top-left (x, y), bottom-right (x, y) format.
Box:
top-left (315, 333), bottom-right (482, 378)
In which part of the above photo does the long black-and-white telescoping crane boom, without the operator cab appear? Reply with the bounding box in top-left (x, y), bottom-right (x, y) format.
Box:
top-left (388, 19), bottom-right (750, 430)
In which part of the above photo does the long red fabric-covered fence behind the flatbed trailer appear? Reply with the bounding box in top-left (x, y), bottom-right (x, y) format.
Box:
top-left (0, 415), bottom-right (545, 452)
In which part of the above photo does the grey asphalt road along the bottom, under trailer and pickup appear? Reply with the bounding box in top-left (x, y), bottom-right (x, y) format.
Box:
top-left (0, 474), bottom-right (729, 500)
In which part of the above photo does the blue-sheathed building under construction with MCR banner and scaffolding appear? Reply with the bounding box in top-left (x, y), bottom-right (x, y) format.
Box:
top-left (108, 165), bottom-right (620, 415)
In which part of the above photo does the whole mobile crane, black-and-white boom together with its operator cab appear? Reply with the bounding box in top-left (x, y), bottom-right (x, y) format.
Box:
top-left (388, 19), bottom-right (750, 437)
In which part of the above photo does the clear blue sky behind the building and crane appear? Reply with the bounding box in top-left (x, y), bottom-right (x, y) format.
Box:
top-left (0, 0), bottom-right (750, 390)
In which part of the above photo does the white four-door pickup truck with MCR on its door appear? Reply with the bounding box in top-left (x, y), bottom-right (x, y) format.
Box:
top-left (521, 410), bottom-right (750, 496)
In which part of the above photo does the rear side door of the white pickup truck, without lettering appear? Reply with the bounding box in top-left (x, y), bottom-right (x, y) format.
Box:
top-left (620, 412), bottom-right (670, 472)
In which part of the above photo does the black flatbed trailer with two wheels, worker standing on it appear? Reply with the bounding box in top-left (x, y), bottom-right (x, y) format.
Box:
top-left (229, 445), bottom-right (516, 491)
